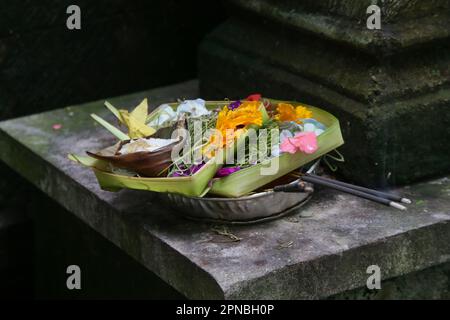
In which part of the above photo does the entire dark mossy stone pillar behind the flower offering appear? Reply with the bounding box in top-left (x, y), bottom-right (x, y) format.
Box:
top-left (199, 0), bottom-right (450, 186)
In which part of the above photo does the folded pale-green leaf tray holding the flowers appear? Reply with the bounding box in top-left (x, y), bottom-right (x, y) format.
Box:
top-left (69, 99), bottom-right (344, 197)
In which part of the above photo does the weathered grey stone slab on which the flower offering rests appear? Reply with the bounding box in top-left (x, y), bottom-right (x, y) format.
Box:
top-left (0, 82), bottom-right (450, 299)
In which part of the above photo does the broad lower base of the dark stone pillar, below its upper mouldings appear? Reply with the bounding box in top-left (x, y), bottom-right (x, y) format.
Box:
top-left (199, 17), bottom-right (450, 186)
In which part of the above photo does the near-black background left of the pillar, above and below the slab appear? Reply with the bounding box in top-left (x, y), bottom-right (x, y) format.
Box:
top-left (0, 0), bottom-right (226, 298)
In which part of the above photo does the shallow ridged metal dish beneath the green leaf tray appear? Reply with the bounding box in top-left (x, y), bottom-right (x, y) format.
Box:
top-left (159, 190), bottom-right (312, 224)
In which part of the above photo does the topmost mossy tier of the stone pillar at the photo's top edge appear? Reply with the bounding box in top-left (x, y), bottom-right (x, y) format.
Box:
top-left (232, 0), bottom-right (450, 55)
